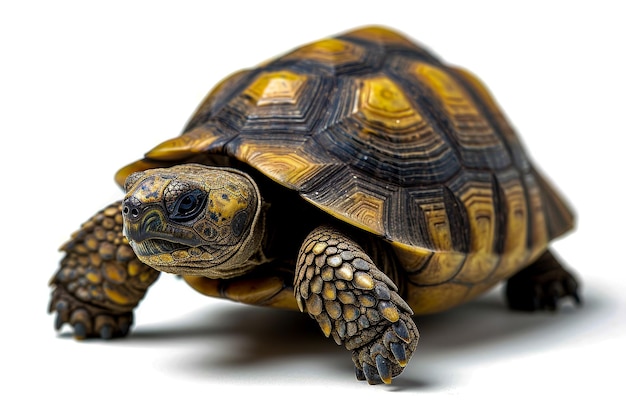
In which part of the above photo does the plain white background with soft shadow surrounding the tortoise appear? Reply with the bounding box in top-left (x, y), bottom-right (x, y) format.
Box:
top-left (0, 0), bottom-right (626, 417)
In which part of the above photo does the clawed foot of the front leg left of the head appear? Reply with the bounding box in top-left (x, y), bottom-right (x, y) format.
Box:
top-left (49, 287), bottom-right (133, 340)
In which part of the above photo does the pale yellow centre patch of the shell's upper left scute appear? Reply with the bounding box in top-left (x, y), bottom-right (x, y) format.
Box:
top-left (245, 71), bottom-right (307, 106)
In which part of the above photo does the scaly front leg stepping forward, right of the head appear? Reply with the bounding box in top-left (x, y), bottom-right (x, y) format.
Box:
top-left (294, 226), bottom-right (419, 384)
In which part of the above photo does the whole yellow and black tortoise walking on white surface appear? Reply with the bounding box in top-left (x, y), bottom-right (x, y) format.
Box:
top-left (50, 26), bottom-right (580, 384)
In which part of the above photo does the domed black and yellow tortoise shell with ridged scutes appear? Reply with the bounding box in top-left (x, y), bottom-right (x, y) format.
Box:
top-left (116, 27), bottom-right (573, 313)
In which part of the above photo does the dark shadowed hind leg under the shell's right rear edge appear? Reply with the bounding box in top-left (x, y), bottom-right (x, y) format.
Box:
top-left (506, 250), bottom-right (581, 311)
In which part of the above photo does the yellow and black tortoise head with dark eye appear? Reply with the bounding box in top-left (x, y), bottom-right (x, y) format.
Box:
top-left (122, 164), bottom-right (263, 278)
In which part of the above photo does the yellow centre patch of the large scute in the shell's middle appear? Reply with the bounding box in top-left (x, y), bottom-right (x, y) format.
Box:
top-left (355, 76), bottom-right (423, 130)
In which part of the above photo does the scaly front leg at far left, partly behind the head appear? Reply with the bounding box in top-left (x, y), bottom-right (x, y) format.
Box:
top-left (49, 202), bottom-right (159, 339)
